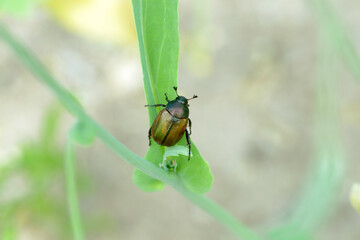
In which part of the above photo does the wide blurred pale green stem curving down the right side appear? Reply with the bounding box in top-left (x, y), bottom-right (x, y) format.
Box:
top-left (270, 23), bottom-right (345, 240)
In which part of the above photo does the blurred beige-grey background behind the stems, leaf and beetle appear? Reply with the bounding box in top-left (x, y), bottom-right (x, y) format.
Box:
top-left (0, 0), bottom-right (360, 240)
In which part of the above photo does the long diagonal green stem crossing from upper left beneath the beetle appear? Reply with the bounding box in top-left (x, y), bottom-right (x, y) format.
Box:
top-left (0, 24), bottom-right (261, 240)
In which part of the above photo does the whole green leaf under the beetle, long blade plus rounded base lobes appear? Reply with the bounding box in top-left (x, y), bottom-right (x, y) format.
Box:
top-left (132, 0), bottom-right (213, 193)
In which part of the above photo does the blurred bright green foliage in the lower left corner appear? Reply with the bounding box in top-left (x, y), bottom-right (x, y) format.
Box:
top-left (0, 109), bottom-right (69, 239)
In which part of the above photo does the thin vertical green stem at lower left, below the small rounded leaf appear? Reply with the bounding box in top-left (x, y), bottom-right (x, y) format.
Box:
top-left (65, 133), bottom-right (84, 240)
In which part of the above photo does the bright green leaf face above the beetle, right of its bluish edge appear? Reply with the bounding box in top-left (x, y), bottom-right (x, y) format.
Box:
top-left (142, 0), bottom-right (179, 103)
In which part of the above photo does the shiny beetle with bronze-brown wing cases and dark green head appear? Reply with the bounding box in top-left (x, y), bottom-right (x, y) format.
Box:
top-left (145, 87), bottom-right (198, 160)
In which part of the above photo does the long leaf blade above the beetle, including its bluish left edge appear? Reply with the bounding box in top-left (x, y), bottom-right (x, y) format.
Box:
top-left (132, 0), bottom-right (179, 123)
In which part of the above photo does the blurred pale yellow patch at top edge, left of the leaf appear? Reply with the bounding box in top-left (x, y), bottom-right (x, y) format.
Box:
top-left (45, 0), bottom-right (136, 44)
